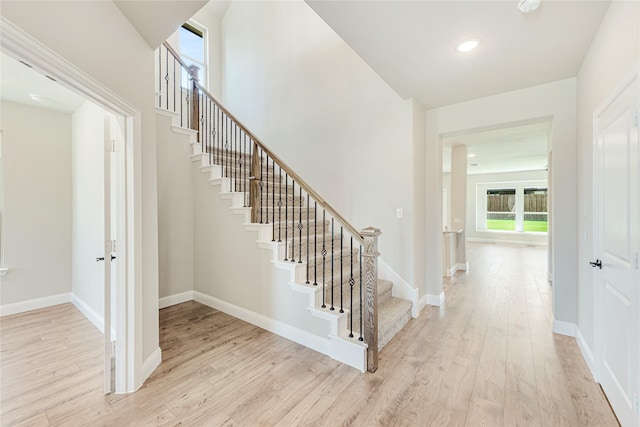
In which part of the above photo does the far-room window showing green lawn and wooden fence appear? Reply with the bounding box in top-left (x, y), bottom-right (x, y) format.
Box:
top-left (476, 181), bottom-right (548, 233)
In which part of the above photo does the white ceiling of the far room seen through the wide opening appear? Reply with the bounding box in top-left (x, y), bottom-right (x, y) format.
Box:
top-left (442, 121), bottom-right (551, 175)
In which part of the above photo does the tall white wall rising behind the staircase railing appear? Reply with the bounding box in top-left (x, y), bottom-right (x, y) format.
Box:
top-left (222, 1), bottom-right (418, 289)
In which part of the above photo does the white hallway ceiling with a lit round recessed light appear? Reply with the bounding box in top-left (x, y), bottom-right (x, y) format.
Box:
top-left (306, 0), bottom-right (609, 109)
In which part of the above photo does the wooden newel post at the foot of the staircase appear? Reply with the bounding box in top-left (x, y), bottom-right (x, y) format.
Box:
top-left (360, 227), bottom-right (382, 372)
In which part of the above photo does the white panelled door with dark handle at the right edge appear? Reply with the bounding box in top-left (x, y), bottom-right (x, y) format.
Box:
top-left (592, 68), bottom-right (640, 426)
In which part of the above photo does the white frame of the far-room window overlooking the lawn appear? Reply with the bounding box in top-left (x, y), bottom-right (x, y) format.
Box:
top-left (476, 180), bottom-right (549, 235)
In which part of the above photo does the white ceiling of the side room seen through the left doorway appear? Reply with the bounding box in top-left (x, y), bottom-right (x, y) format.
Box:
top-left (0, 53), bottom-right (84, 113)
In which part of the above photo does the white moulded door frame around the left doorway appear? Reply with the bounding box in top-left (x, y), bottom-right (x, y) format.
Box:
top-left (0, 17), bottom-right (143, 393)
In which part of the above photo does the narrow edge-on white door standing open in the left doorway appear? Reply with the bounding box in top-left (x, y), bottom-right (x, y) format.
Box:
top-left (103, 115), bottom-right (116, 394)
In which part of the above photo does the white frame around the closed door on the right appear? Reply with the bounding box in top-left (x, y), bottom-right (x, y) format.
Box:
top-left (591, 61), bottom-right (640, 383)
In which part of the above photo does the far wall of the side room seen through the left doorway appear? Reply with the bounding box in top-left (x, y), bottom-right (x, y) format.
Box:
top-left (0, 101), bottom-right (71, 305)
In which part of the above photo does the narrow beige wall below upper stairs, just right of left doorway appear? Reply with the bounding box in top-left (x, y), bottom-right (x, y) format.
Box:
top-left (156, 114), bottom-right (194, 298)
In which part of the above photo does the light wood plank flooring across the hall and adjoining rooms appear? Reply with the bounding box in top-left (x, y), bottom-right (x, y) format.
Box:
top-left (0, 244), bottom-right (617, 427)
